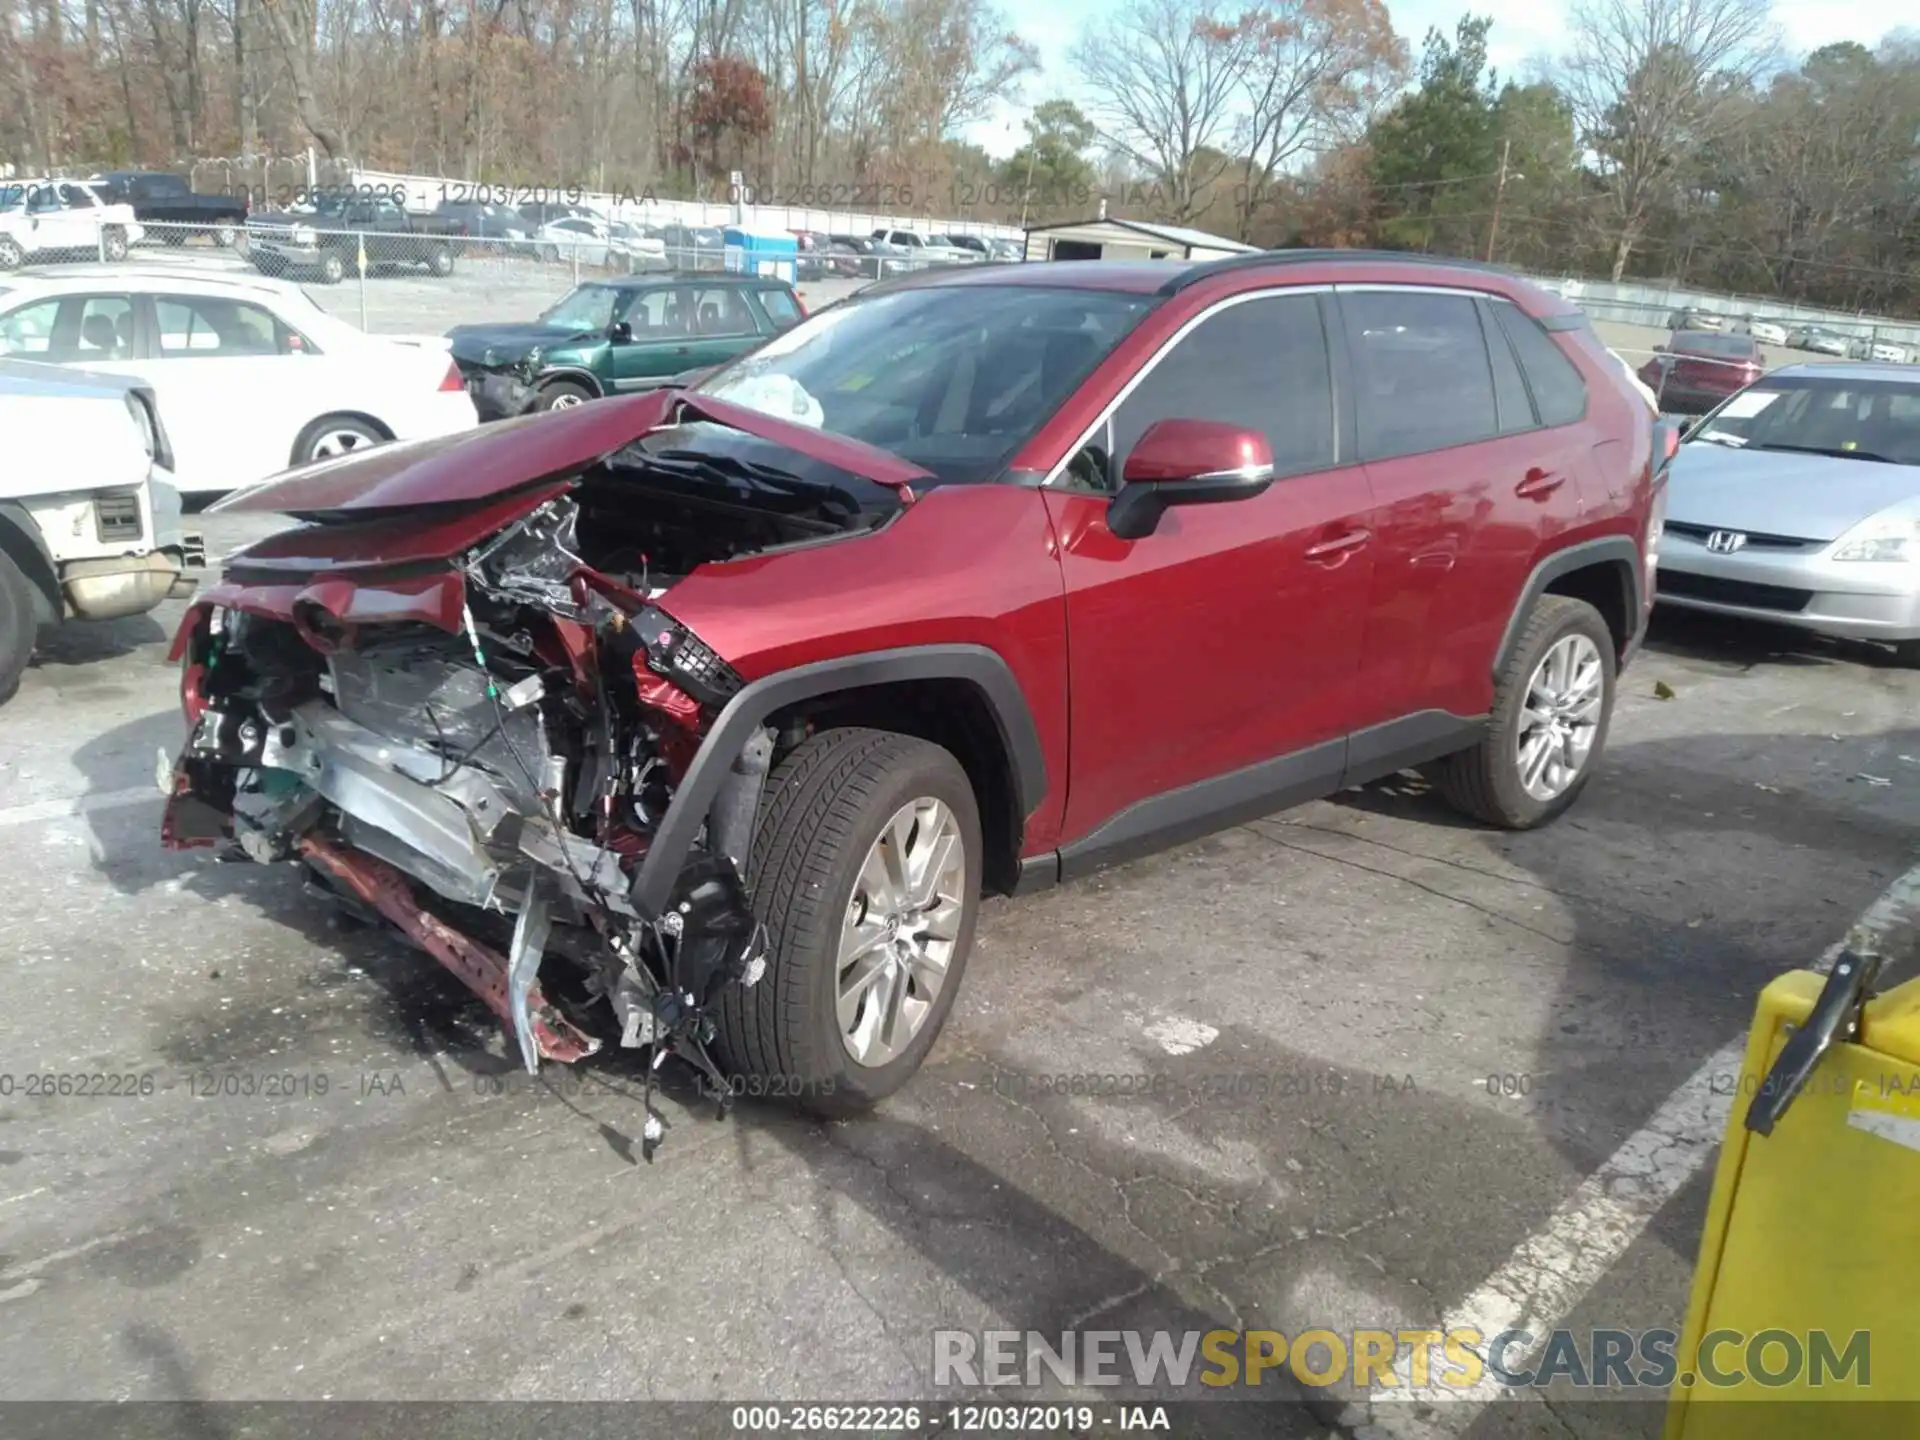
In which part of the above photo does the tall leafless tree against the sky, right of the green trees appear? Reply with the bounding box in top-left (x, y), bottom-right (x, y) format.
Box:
top-left (1561, 0), bottom-right (1780, 280)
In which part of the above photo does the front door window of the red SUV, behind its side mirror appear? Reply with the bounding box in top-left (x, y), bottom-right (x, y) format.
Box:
top-left (1114, 296), bottom-right (1336, 476)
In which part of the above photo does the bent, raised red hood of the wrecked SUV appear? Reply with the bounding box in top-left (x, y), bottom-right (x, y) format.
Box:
top-left (209, 390), bottom-right (933, 522)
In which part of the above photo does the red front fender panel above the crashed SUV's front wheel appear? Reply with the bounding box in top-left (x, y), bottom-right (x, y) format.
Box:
top-left (659, 486), bottom-right (1068, 854)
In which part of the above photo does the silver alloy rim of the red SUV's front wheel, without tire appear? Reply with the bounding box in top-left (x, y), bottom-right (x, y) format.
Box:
top-left (835, 797), bottom-right (968, 1068)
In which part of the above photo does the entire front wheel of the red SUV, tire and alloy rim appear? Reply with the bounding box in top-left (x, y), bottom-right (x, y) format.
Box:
top-left (716, 730), bottom-right (983, 1116)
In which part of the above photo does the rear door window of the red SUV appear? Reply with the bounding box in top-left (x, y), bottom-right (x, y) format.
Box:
top-left (1340, 290), bottom-right (1500, 461)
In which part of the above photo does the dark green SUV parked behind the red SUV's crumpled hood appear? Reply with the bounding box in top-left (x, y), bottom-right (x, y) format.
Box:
top-left (447, 271), bottom-right (806, 420)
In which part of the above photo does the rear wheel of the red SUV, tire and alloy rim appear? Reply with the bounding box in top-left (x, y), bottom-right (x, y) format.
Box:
top-left (1427, 595), bottom-right (1617, 829)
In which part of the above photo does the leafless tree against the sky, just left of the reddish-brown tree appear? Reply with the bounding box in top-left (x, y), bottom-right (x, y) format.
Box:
top-left (1071, 0), bottom-right (1248, 221)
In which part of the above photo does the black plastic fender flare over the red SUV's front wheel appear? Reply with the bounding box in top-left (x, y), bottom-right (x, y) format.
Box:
top-left (628, 645), bottom-right (1046, 918)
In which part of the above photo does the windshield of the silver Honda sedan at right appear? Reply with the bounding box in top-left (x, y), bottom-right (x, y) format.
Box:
top-left (1688, 378), bottom-right (1920, 465)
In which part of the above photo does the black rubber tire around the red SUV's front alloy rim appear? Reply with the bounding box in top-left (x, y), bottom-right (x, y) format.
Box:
top-left (714, 730), bottom-right (985, 1117)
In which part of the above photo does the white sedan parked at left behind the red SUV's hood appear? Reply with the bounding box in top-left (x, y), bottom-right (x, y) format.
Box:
top-left (0, 267), bottom-right (480, 493)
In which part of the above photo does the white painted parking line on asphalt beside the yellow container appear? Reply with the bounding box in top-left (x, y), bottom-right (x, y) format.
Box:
top-left (1342, 866), bottom-right (1920, 1440)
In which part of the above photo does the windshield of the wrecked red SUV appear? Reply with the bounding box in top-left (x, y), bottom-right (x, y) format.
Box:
top-left (699, 286), bottom-right (1154, 484)
